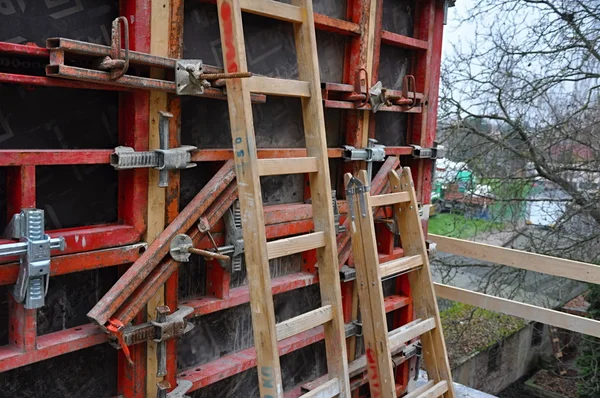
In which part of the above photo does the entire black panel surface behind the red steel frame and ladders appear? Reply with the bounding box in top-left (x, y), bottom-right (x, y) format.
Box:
top-left (0, 0), bottom-right (413, 398)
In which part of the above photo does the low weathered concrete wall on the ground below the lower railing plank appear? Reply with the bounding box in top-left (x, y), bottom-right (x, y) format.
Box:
top-left (452, 323), bottom-right (552, 394)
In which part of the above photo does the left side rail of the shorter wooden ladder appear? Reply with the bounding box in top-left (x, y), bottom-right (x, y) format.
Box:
top-left (344, 170), bottom-right (396, 398)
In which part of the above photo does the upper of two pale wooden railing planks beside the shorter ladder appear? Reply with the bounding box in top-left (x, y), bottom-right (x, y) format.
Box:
top-left (429, 234), bottom-right (600, 284)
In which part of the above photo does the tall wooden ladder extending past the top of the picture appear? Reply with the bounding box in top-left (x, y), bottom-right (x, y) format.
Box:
top-left (217, 0), bottom-right (350, 397)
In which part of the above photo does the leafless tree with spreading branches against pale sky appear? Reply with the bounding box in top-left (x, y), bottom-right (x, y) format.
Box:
top-left (440, 0), bottom-right (600, 261)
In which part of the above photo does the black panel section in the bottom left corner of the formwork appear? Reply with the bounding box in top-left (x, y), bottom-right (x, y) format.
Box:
top-left (0, 344), bottom-right (117, 398)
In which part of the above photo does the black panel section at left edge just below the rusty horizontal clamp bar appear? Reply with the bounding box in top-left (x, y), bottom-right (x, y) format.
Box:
top-left (0, 86), bottom-right (118, 149)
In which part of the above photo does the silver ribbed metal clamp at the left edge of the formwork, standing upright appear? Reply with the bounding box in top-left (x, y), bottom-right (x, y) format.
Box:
top-left (0, 209), bottom-right (66, 309)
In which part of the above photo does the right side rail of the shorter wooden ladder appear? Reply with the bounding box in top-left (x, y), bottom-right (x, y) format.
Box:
top-left (389, 167), bottom-right (455, 398)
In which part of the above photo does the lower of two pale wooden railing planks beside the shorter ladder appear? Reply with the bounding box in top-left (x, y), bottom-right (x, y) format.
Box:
top-left (435, 283), bottom-right (600, 337)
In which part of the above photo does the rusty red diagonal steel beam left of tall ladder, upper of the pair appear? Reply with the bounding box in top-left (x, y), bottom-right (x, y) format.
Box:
top-left (88, 161), bottom-right (235, 327)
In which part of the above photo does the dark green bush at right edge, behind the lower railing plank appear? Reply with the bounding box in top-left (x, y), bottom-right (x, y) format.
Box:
top-left (577, 285), bottom-right (600, 398)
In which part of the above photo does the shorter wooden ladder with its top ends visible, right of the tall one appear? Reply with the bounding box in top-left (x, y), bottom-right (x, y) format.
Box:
top-left (345, 167), bottom-right (454, 398)
